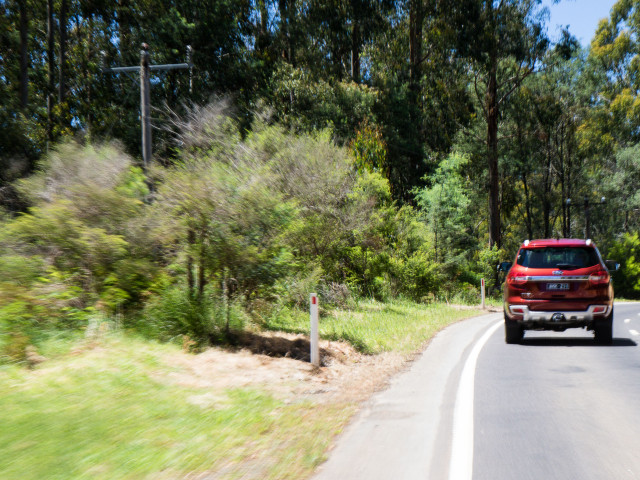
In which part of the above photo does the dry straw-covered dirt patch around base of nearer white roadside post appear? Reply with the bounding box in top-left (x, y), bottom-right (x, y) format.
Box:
top-left (166, 332), bottom-right (407, 407)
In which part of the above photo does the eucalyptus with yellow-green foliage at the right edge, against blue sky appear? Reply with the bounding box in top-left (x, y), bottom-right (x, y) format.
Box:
top-left (579, 0), bottom-right (640, 238)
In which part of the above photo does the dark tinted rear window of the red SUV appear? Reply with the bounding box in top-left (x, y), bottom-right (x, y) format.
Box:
top-left (516, 247), bottom-right (600, 270)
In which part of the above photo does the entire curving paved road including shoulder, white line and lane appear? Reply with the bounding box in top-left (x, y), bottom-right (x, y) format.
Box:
top-left (314, 303), bottom-right (640, 480)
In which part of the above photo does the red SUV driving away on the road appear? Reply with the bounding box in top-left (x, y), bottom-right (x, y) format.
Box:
top-left (498, 239), bottom-right (618, 344)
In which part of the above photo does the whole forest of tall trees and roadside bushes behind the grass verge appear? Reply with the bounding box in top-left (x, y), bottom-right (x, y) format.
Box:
top-left (0, 0), bottom-right (640, 360)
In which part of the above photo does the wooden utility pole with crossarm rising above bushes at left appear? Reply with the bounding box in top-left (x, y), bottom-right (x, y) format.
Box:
top-left (102, 43), bottom-right (193, 171)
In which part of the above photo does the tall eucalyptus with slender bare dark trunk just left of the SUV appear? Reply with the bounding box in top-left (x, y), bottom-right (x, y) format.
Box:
top-left (449, 0), bottom-right (548, 246)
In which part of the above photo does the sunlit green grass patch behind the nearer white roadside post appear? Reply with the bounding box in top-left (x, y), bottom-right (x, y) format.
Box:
top-left (268, 300), bottom-right (482, 354)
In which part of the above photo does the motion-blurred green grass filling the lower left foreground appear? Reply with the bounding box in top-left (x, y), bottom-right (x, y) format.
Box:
top-left (0, 336), bottom-right (347, 480)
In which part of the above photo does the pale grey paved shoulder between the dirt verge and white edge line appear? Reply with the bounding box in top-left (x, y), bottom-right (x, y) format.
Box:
top-left (313, 314), bottom-right (501, 480)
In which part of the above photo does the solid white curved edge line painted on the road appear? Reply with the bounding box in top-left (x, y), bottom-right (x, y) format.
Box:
top-left (449, 321), bottom-right (504, 480)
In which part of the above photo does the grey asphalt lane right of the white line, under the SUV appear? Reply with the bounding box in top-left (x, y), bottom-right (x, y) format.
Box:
top-left (473, 304), bottom-right (640, 480)
